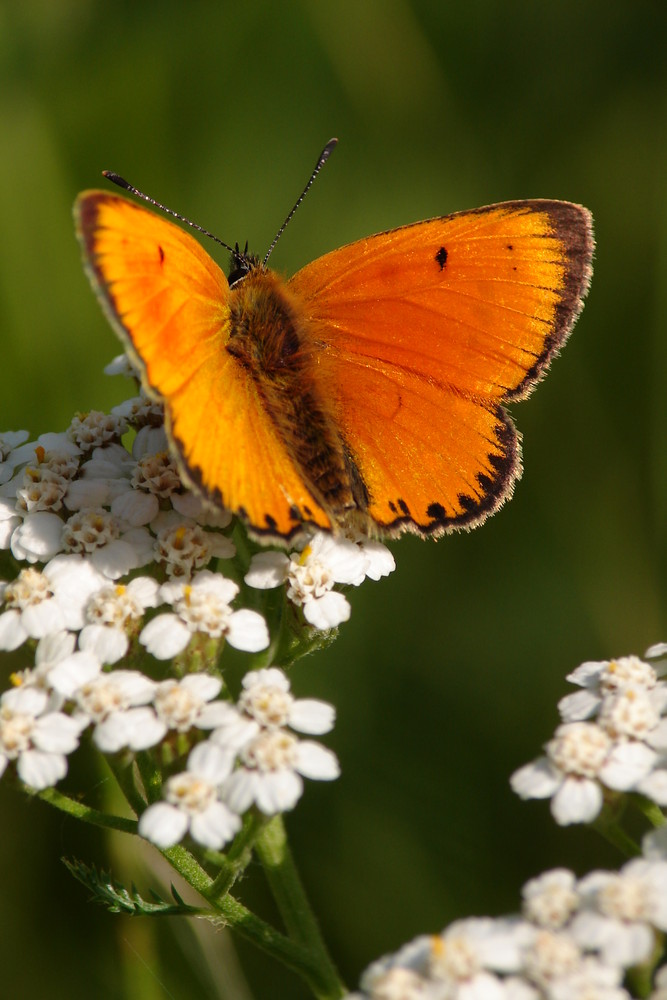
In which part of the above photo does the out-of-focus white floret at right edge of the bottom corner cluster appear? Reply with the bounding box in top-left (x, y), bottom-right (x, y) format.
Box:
top-left (571, 858), bottom-right (667, 967)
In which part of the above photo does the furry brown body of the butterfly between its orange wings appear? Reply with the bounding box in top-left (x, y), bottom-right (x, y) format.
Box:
top-left (227, 268), bottom-right (364, 521)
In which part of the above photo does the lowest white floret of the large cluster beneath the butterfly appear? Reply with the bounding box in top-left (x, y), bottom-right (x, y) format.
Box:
top-left (139, 742), bottom-right (241, 850)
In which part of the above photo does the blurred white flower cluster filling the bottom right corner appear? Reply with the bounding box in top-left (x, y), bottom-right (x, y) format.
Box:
top-left (348, 834), bottom-right (667, 1000)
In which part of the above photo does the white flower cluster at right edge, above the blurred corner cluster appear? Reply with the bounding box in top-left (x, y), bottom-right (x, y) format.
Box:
top-left (511, 643), bottom-right (667, 825)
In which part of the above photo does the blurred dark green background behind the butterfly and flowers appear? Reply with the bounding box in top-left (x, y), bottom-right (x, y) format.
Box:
top-left (0, 0), bottom-right (667, 1000)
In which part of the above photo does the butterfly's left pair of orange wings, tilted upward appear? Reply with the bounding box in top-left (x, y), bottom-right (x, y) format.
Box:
top-left (75, 191), bottom-right (331, 536)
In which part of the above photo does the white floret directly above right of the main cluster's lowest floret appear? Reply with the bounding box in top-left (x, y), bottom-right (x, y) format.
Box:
top-left (223, 729), bottom-right (340, 815)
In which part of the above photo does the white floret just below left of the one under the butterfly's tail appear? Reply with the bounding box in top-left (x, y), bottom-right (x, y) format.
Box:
top-left (139, 570), bottom-right (269, 660)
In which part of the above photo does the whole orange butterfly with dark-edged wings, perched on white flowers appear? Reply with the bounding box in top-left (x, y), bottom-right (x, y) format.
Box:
top-left (75, 142), bottom-right (593, 539)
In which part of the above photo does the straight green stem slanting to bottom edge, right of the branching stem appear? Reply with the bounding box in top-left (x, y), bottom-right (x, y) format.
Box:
top-left (255, 816), bottom-right (345, 997)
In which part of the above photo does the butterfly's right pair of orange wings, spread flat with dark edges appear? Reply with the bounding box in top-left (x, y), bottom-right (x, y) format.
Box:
top-left (288, 201), bottom-right (593, 535)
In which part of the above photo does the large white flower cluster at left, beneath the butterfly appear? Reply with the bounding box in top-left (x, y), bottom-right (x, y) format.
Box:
top-left (0, 359), bottom-right (394, 832)
